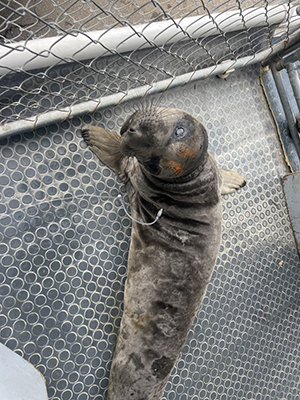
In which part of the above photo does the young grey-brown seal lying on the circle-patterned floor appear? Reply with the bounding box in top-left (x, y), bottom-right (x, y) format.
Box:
top-left (82, 107), bottom-right (245, 400)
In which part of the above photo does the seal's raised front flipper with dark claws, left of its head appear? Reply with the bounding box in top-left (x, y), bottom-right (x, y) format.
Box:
top-left (82, 125), bottom-right (125, 174)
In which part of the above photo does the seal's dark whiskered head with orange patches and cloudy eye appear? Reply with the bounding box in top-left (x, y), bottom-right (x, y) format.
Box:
top-left (120, 107), bottom-right (208, 180)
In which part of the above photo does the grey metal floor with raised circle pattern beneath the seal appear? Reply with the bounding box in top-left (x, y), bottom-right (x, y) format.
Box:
top-left (0, 67), bottom-right (300, 400)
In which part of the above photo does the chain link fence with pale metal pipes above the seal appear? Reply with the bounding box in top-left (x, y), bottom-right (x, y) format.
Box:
top-left (0, 0), bottom-right (299, 136)
